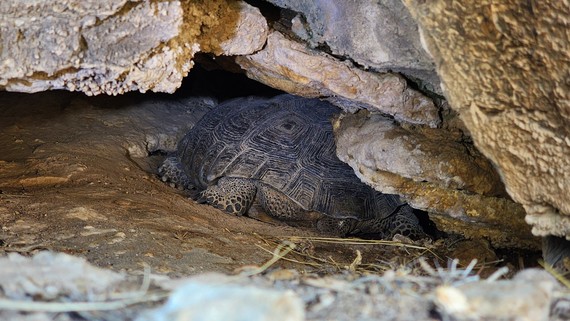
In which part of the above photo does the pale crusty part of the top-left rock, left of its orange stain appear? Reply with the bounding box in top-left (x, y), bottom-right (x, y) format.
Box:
top-left (0, 1), bottom-right (186, 95)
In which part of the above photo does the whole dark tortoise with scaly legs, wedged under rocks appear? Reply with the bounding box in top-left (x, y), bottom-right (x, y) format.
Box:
top-left (159, 95), bottom-right (423, 238)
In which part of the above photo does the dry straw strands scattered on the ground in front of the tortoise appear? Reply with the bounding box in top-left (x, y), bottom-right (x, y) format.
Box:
top-left (243, 234), bottom-right (508, 282)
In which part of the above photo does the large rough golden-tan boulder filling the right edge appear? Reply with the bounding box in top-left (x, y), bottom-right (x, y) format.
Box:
top-left (404, 0), bottom-right (570, 237)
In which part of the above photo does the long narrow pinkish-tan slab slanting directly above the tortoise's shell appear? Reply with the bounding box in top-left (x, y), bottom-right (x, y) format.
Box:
top-left (236, 32), bottom-right (441, 127)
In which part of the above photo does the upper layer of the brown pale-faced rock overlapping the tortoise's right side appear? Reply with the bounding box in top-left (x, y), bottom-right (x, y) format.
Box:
top-left (335, 112), bottom-right (505, 196)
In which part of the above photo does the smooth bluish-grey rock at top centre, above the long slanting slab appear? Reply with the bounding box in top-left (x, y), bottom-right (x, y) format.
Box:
top-left (262, 0), bottom-right (440, 93)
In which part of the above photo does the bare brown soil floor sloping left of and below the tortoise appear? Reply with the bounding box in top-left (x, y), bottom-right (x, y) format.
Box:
top-left (0, 92), bottom-right (532, 276)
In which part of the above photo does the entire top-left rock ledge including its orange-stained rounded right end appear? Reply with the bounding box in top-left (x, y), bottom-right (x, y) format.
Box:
top-left (0, 0), bottom-right (267, 95)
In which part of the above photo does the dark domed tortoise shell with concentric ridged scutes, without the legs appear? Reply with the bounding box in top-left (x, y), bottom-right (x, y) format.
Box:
top-left (178, 95), bottom-right (401, 220)
